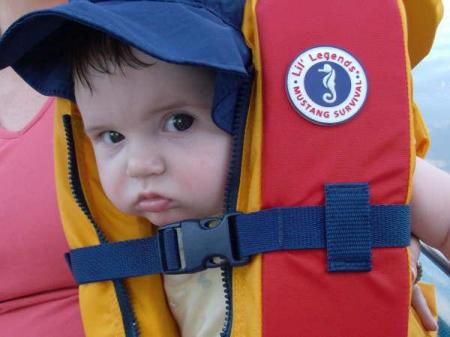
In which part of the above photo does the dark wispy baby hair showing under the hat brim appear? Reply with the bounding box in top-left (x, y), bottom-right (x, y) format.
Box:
top-left (65, 24), bottom-right (153, 92)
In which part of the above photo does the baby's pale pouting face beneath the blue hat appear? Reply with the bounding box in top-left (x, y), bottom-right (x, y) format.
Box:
top-left (75, 53), bottom-right (231, 226)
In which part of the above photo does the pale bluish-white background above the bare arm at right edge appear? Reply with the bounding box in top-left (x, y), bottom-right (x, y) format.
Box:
top-left (413, 0), bottom-right (450, 172)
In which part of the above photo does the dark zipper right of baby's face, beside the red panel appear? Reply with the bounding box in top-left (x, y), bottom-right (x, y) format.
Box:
top-left (220, 75), bottom-right (253, 337)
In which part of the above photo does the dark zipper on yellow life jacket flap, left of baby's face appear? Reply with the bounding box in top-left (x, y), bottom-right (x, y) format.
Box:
top-left (63, 115), bottom-right (140, 337)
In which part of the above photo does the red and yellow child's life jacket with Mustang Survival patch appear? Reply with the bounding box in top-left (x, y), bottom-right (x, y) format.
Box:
top-left (0, 0), bottom-right (442, 337)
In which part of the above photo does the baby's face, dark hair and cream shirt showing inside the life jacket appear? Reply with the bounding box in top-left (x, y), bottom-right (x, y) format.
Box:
top-left (72, 31), bottom-right (231, 337)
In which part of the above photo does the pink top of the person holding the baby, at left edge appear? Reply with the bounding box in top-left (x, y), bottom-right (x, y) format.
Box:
top-left (0, 99), bottom-right (84, 337)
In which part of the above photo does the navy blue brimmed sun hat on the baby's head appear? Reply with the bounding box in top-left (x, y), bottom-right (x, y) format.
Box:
top-left (0, 0), bottom-right (251, 132)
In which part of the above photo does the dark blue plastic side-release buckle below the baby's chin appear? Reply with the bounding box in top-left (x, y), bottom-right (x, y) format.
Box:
top-left (158, 213), bottom-right (250, 274)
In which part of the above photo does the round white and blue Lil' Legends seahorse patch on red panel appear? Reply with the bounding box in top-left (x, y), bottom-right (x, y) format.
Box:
top-left (286, 46), bottom-right (368, 125)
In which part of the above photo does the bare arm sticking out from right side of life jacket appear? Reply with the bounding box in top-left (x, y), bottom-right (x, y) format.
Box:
top-left (411, 158), bottom-right (450, 258)
